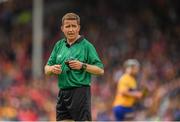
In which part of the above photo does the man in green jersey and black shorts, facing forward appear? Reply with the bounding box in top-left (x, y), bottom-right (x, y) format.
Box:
top-left (45, 13), bottom-right (104, 121)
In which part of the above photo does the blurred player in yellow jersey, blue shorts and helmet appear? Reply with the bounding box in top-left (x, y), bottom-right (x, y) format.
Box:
top-left (113, 59), bottom-right (142, 121)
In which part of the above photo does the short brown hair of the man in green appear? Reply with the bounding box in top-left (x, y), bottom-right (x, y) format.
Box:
top-left (62, 13), bottom-right (80, 25)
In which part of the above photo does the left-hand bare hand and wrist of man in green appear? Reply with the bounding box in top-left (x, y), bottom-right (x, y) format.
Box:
top-left (45, 64), bottom-right (62, 75)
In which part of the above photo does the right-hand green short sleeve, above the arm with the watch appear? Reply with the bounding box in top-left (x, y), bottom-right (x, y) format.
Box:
top-left (87, 44), bottom-right (104, 69)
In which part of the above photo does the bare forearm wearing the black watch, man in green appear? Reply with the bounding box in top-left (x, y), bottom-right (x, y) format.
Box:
top-left (86, 64), bottom-right (104, 75)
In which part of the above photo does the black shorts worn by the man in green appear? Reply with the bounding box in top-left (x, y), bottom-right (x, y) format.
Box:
top-left (56, 86), bottom-right (91, 121)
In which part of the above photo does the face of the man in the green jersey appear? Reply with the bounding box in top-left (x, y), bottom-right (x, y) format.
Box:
top-left (61, 20), bottom-right (80, 42)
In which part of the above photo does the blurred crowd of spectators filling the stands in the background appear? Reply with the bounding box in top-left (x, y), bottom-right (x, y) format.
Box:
top-left (0, 0), bottom-right (180, 121)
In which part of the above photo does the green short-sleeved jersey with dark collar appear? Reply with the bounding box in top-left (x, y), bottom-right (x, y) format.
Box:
top-left (47, 36), bottom-right (103, 89)
